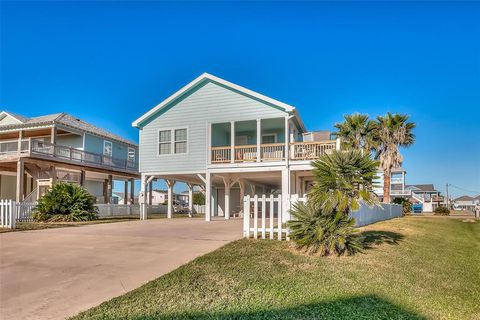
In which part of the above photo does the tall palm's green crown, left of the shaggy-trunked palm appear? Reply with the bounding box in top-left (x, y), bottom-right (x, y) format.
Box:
top-left (334, 113), bottom-right (375, 150)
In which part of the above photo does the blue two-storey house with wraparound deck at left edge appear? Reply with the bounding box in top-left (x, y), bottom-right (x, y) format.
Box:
top-left (0, 111), bottom-right (139, 203)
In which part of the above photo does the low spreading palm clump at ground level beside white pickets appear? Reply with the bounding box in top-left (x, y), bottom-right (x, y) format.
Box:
top-left (287, 201), bottom-right (362, 256)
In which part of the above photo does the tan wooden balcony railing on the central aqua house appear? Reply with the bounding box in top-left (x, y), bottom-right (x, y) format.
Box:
top-left (210, 140), bottom-right (337, 164)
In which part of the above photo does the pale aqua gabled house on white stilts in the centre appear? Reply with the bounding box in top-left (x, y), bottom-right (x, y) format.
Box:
top-left (133, 73), bottom-right (340, 221)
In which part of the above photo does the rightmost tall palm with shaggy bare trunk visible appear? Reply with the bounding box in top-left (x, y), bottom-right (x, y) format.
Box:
top-left (375, 112), bottom-right (415, 203)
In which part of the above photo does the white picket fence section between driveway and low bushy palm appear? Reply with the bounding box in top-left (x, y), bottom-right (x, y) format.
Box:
top-left (243, 195), bottom-right (289, 240)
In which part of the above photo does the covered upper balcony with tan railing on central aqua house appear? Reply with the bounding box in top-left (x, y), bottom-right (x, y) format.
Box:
top-left (209, 118), bottom-right (339, 165)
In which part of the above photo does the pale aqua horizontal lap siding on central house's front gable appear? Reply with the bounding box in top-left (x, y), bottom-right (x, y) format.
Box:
top-left (140, 83), bottom-right (285, 172)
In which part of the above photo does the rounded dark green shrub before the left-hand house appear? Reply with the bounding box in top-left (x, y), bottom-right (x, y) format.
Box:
top-left (33, 182), bottom-right (98, 222)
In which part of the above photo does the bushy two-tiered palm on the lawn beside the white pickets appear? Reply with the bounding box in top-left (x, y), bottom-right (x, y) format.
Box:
top-left (287, 150), bottom-right (378, 255)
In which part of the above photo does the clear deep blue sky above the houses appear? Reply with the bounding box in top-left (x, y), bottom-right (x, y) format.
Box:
top-left (0, 2), bottom-right (480, 195)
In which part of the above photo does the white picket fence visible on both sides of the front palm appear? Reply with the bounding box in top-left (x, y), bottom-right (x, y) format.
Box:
top-left (243, 194), bottom-right (402, 240)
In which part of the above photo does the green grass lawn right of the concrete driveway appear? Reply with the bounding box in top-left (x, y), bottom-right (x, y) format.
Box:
top-left (74, 217), bottom-right (480, 320)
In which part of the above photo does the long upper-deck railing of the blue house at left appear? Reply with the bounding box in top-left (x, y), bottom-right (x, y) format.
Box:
top-left (0, 139), bottom-right (137, 171)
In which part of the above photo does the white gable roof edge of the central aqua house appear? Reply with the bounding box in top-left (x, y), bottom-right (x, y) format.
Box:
top-left (132, 72), bottom-right (303, 128)
